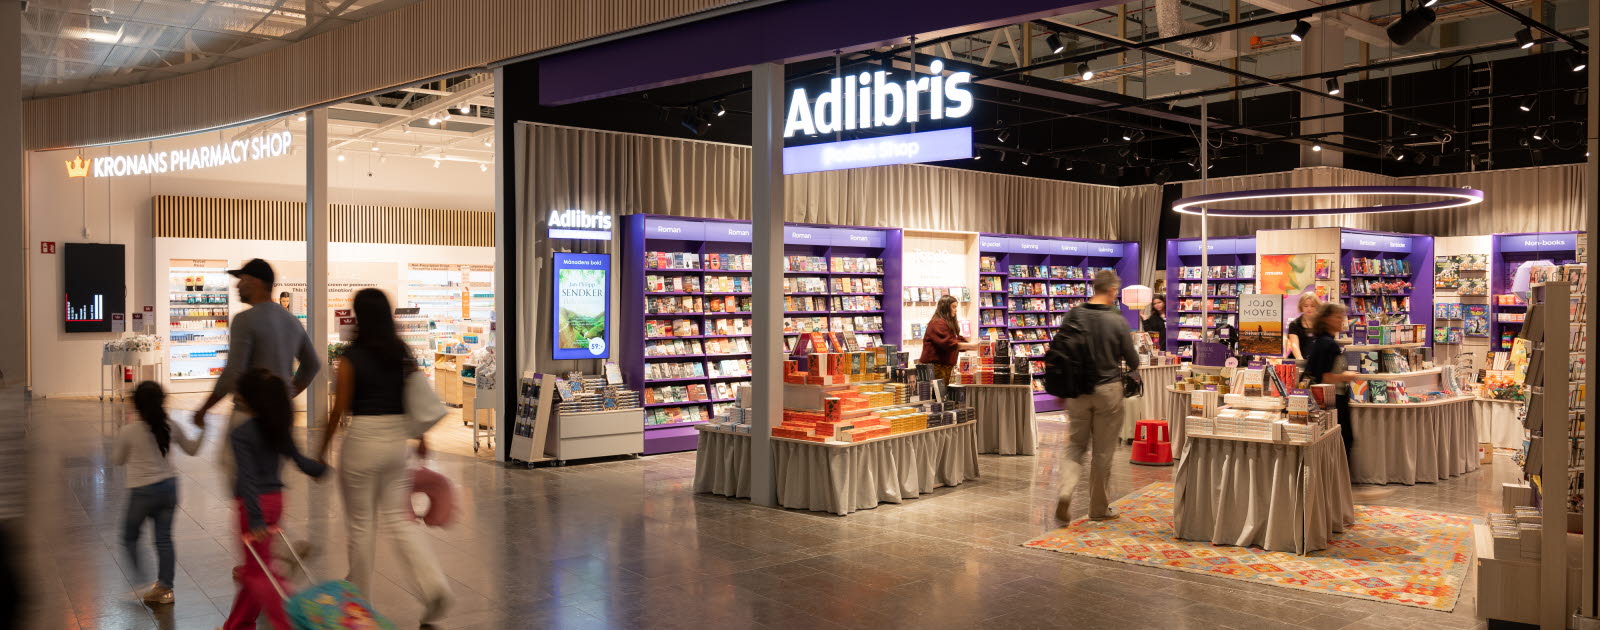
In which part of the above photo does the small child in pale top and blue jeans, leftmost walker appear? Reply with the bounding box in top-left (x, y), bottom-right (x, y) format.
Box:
top-left (110, 381), bottom-right (205, 604)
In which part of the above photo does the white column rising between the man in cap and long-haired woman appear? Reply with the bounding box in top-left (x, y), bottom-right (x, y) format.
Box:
top-left (306, 109), bottom-right (333, 429)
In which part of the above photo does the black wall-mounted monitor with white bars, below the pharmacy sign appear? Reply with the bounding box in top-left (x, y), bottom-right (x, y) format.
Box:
top-left (61, 243), bottom-right (126, 333)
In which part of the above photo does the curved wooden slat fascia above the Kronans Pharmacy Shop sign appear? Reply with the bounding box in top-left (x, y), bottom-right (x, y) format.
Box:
top-left (22, 0), bottom-right (742, 150)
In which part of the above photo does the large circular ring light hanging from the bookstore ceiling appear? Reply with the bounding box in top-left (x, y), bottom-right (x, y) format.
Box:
top-left (1173, 185), bottom-right (1483, 217)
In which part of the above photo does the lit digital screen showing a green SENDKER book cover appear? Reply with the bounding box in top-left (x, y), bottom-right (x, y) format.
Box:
top-left (552, 251), bottom-right (611, 360)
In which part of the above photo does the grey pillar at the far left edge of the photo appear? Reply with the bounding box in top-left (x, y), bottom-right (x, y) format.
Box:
top-left (0, 2), bottom-right (24, 387)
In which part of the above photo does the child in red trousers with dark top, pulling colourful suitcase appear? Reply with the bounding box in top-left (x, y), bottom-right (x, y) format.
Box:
top-left (222, 368), bottom-right (328, 630)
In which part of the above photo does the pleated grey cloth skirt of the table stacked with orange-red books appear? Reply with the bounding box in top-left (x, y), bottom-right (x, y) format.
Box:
top-left (694, 422), bottom-right (978, 515)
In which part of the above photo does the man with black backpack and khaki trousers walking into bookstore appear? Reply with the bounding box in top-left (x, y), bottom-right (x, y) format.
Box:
top-left (1045, 269), bottom-right (1139, 521)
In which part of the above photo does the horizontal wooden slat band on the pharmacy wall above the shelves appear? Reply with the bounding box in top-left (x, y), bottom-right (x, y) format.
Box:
top-left (152, 195), bottom-right (494, 248)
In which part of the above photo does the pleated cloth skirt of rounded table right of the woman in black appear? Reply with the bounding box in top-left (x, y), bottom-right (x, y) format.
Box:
top-left (1350, 397), bottom-right (1480, 486)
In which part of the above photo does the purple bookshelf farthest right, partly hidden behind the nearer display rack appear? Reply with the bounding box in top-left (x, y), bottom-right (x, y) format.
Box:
top-left (1491, 232), bottom-right (1579, 352)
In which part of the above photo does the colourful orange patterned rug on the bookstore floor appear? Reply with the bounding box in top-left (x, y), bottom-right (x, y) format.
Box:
top-left (1022, 483), bottom-right (1472, 612)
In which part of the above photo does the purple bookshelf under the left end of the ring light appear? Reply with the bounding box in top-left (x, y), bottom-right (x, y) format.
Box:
top-left (1162, 237), bottom-right (1256, 358)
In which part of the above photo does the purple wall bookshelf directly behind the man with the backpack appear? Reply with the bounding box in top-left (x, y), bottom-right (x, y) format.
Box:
top-left (976, 233), bottom-right (1139, 411)
